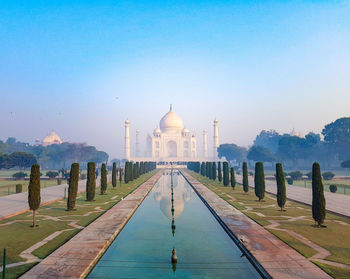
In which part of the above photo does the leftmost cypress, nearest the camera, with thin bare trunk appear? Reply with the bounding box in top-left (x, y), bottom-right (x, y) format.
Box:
top-left (28, 164), bottom-right (41, 228)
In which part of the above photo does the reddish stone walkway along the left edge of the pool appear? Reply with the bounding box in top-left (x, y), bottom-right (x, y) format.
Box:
top-left (21, 171), bottom-right (162, 279)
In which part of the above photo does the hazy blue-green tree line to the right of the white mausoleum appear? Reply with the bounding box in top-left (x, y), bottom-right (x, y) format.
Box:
top-left (218, 117), bottom-right (350, 169)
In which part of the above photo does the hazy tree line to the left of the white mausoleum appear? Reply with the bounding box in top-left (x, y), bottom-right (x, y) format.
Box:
top-left (0, 138), bottom-right (108, 169)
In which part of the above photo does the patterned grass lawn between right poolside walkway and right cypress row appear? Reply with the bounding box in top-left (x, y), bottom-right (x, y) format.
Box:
top-left (190, 172), bottom-right (350, 278)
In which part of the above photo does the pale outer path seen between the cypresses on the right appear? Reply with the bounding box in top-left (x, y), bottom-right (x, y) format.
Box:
top-left (236, 174), bottom-right (350, 217)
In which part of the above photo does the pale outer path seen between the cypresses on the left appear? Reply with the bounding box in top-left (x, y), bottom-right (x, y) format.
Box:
top-left (0, 175), bottom-right (112, 220)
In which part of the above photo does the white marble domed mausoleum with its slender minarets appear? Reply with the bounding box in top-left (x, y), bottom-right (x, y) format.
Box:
top-left (125, 105), bottom-right (219, 162)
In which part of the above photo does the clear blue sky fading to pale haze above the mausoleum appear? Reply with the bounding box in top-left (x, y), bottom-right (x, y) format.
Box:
top-left (0, 0), bottom-right (350, 158)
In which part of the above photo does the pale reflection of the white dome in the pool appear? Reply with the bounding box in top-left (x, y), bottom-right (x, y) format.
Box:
top-left (153, 171), bottom-right (191, 220)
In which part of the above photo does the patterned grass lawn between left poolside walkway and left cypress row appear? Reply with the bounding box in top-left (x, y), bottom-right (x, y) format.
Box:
top-left (0, 171), bottom-right (155, 278)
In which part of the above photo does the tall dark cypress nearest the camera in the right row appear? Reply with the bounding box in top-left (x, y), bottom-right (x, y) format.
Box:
top-left (312, 162), bottom-right (326, 227)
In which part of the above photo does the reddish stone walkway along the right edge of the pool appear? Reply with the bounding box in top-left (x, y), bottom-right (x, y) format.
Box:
top-left (183, 171), bottom-right (332, 279)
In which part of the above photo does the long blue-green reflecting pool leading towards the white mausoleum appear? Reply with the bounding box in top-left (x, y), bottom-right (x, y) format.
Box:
top-left (88, 170), bottom-right (261, 279)
